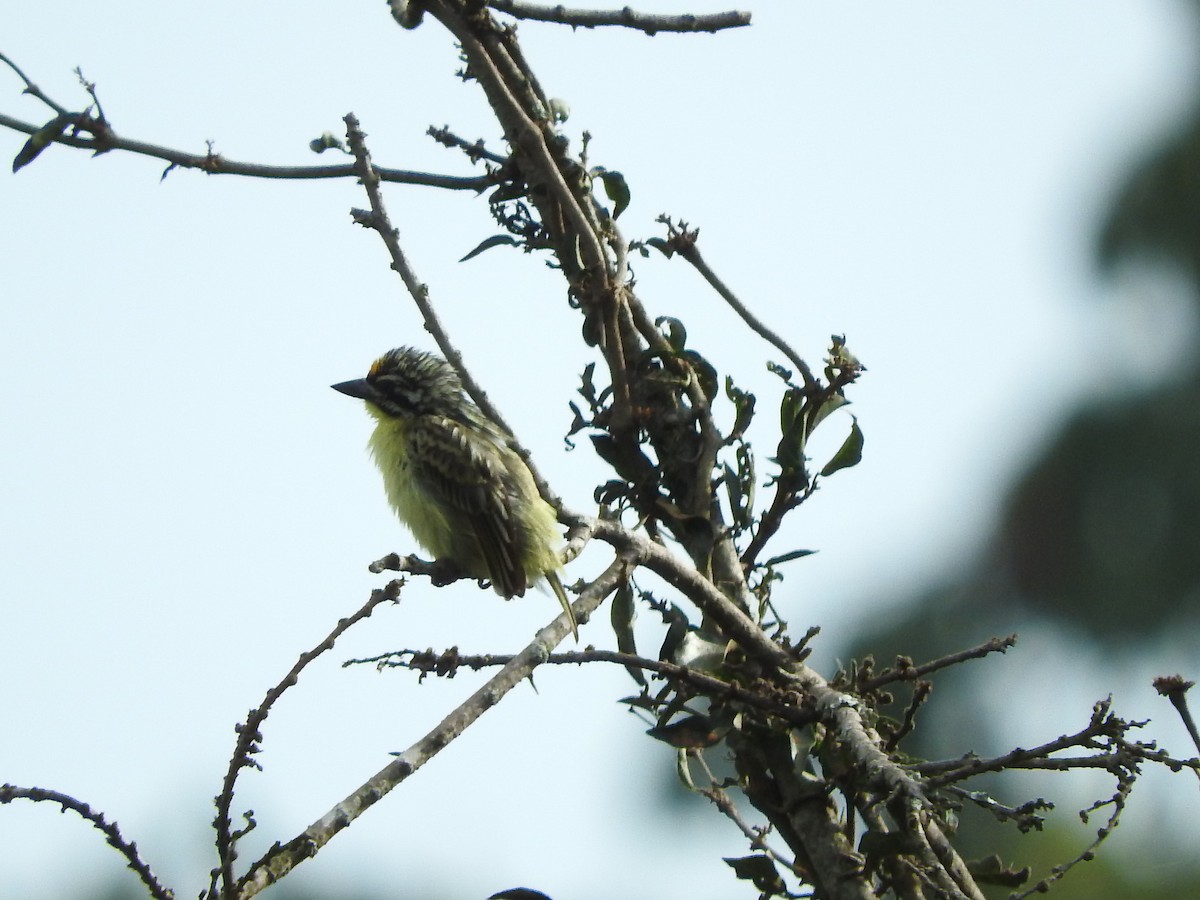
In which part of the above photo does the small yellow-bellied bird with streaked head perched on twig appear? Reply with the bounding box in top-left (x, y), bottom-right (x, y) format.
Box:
top-left (330, 347), bottom-right (580, 641)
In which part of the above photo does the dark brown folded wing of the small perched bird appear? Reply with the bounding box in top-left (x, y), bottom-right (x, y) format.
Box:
top-left (410, 416), bottom-right (526, 596)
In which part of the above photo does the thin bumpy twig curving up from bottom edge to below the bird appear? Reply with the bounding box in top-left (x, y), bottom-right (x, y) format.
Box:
top-left (208, 578), bottom-right (403, 898)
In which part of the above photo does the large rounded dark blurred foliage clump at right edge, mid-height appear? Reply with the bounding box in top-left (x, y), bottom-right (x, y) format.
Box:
top-left (997, 384), bottom-right (1200, 644)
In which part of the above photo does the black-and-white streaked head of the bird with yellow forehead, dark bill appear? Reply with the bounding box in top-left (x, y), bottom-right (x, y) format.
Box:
top-left (331, 347), bottom-right (463, 419)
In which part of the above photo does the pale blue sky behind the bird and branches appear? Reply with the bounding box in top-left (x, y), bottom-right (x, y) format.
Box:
top-left (0, 0), bottom-right (1195, 900)
